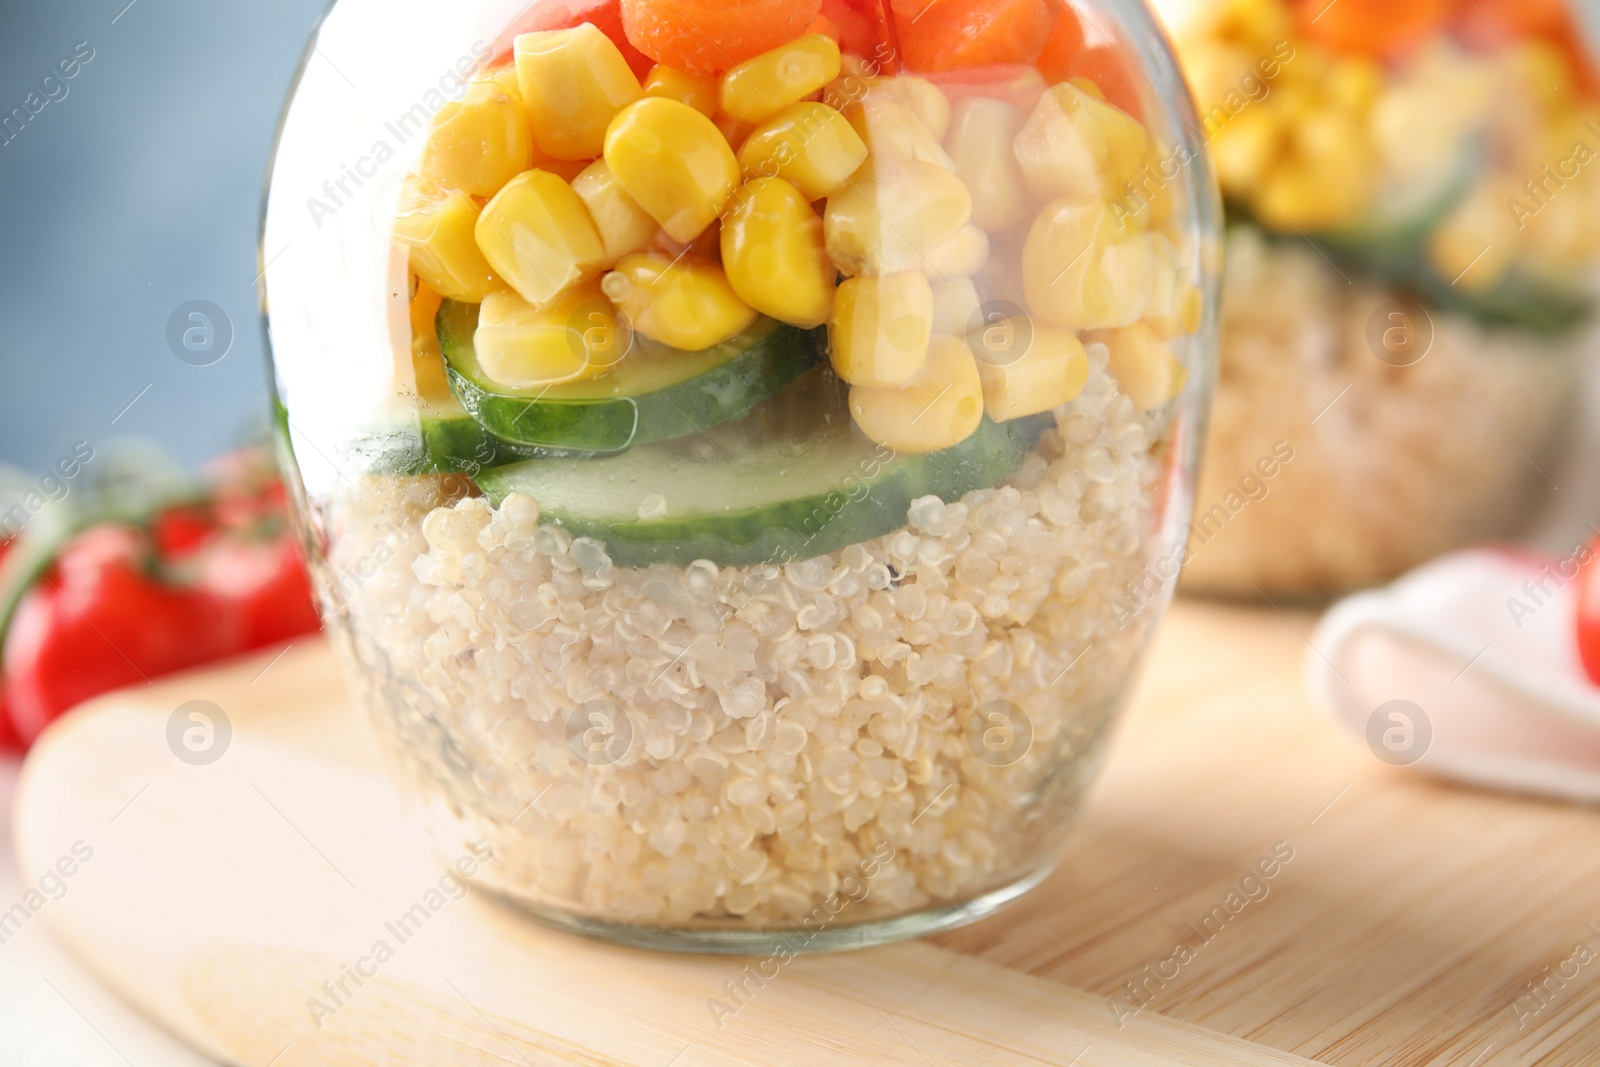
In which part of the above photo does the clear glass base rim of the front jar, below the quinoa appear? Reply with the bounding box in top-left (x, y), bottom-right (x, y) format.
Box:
top-left (493, 864), bottom-right (1054, 957)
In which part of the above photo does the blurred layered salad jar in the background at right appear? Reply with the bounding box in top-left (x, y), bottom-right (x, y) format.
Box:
top-left (1165, 0), bottom-right (1600, 597)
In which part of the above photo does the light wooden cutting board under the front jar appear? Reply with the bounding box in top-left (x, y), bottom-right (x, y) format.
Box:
top-left (12, 605), bottom-right (1600, 1067)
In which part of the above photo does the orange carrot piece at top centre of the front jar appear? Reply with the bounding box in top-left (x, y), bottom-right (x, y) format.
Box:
top-left (622, 0), bottom-right (822, 74)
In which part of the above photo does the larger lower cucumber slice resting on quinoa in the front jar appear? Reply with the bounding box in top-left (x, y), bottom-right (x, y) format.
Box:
top-left (478, 368), bottom-right (1053, 566)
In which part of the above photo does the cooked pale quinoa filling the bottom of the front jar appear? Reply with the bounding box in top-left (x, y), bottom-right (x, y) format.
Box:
top-left (318, 356), bottom-right (1165, 929)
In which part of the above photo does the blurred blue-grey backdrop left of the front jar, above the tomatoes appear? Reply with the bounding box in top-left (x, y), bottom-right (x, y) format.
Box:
top-left (0, 0), bottom-right (325, 470)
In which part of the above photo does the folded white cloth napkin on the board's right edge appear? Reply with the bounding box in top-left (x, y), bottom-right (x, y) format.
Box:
top-left (1307, 549), bottom-right (1600, 803)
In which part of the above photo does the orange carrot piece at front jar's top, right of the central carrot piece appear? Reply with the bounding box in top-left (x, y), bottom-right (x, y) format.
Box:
top-left (890, 0), bottom-right (1051, 70)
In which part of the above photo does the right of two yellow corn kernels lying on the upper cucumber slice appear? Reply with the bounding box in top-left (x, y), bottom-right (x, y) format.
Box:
top-left (602, 253), bottom-right (755, 352)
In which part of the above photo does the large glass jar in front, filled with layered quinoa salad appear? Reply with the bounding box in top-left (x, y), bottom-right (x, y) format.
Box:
top-left (262, 0), bottom-right (1219, 952)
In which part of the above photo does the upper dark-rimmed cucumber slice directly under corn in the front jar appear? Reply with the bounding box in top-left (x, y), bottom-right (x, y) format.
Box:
top-left (438, 301), bottom-right (826, 454)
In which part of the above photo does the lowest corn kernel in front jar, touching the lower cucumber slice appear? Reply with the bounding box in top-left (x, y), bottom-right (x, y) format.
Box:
top-left (850, 336), bottom-right (984, 454)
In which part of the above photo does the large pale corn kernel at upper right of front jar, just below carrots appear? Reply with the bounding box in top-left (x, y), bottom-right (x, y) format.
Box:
top-left (1016, 85), bottom-right (1150, 200)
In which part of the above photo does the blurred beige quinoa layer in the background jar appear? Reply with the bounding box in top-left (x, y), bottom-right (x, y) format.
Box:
top-left (1184, 227), bottom-right (1581, 597)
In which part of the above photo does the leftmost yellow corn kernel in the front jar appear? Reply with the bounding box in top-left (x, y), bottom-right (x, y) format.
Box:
top-left (395, 178), bottom-right (501, 304)
